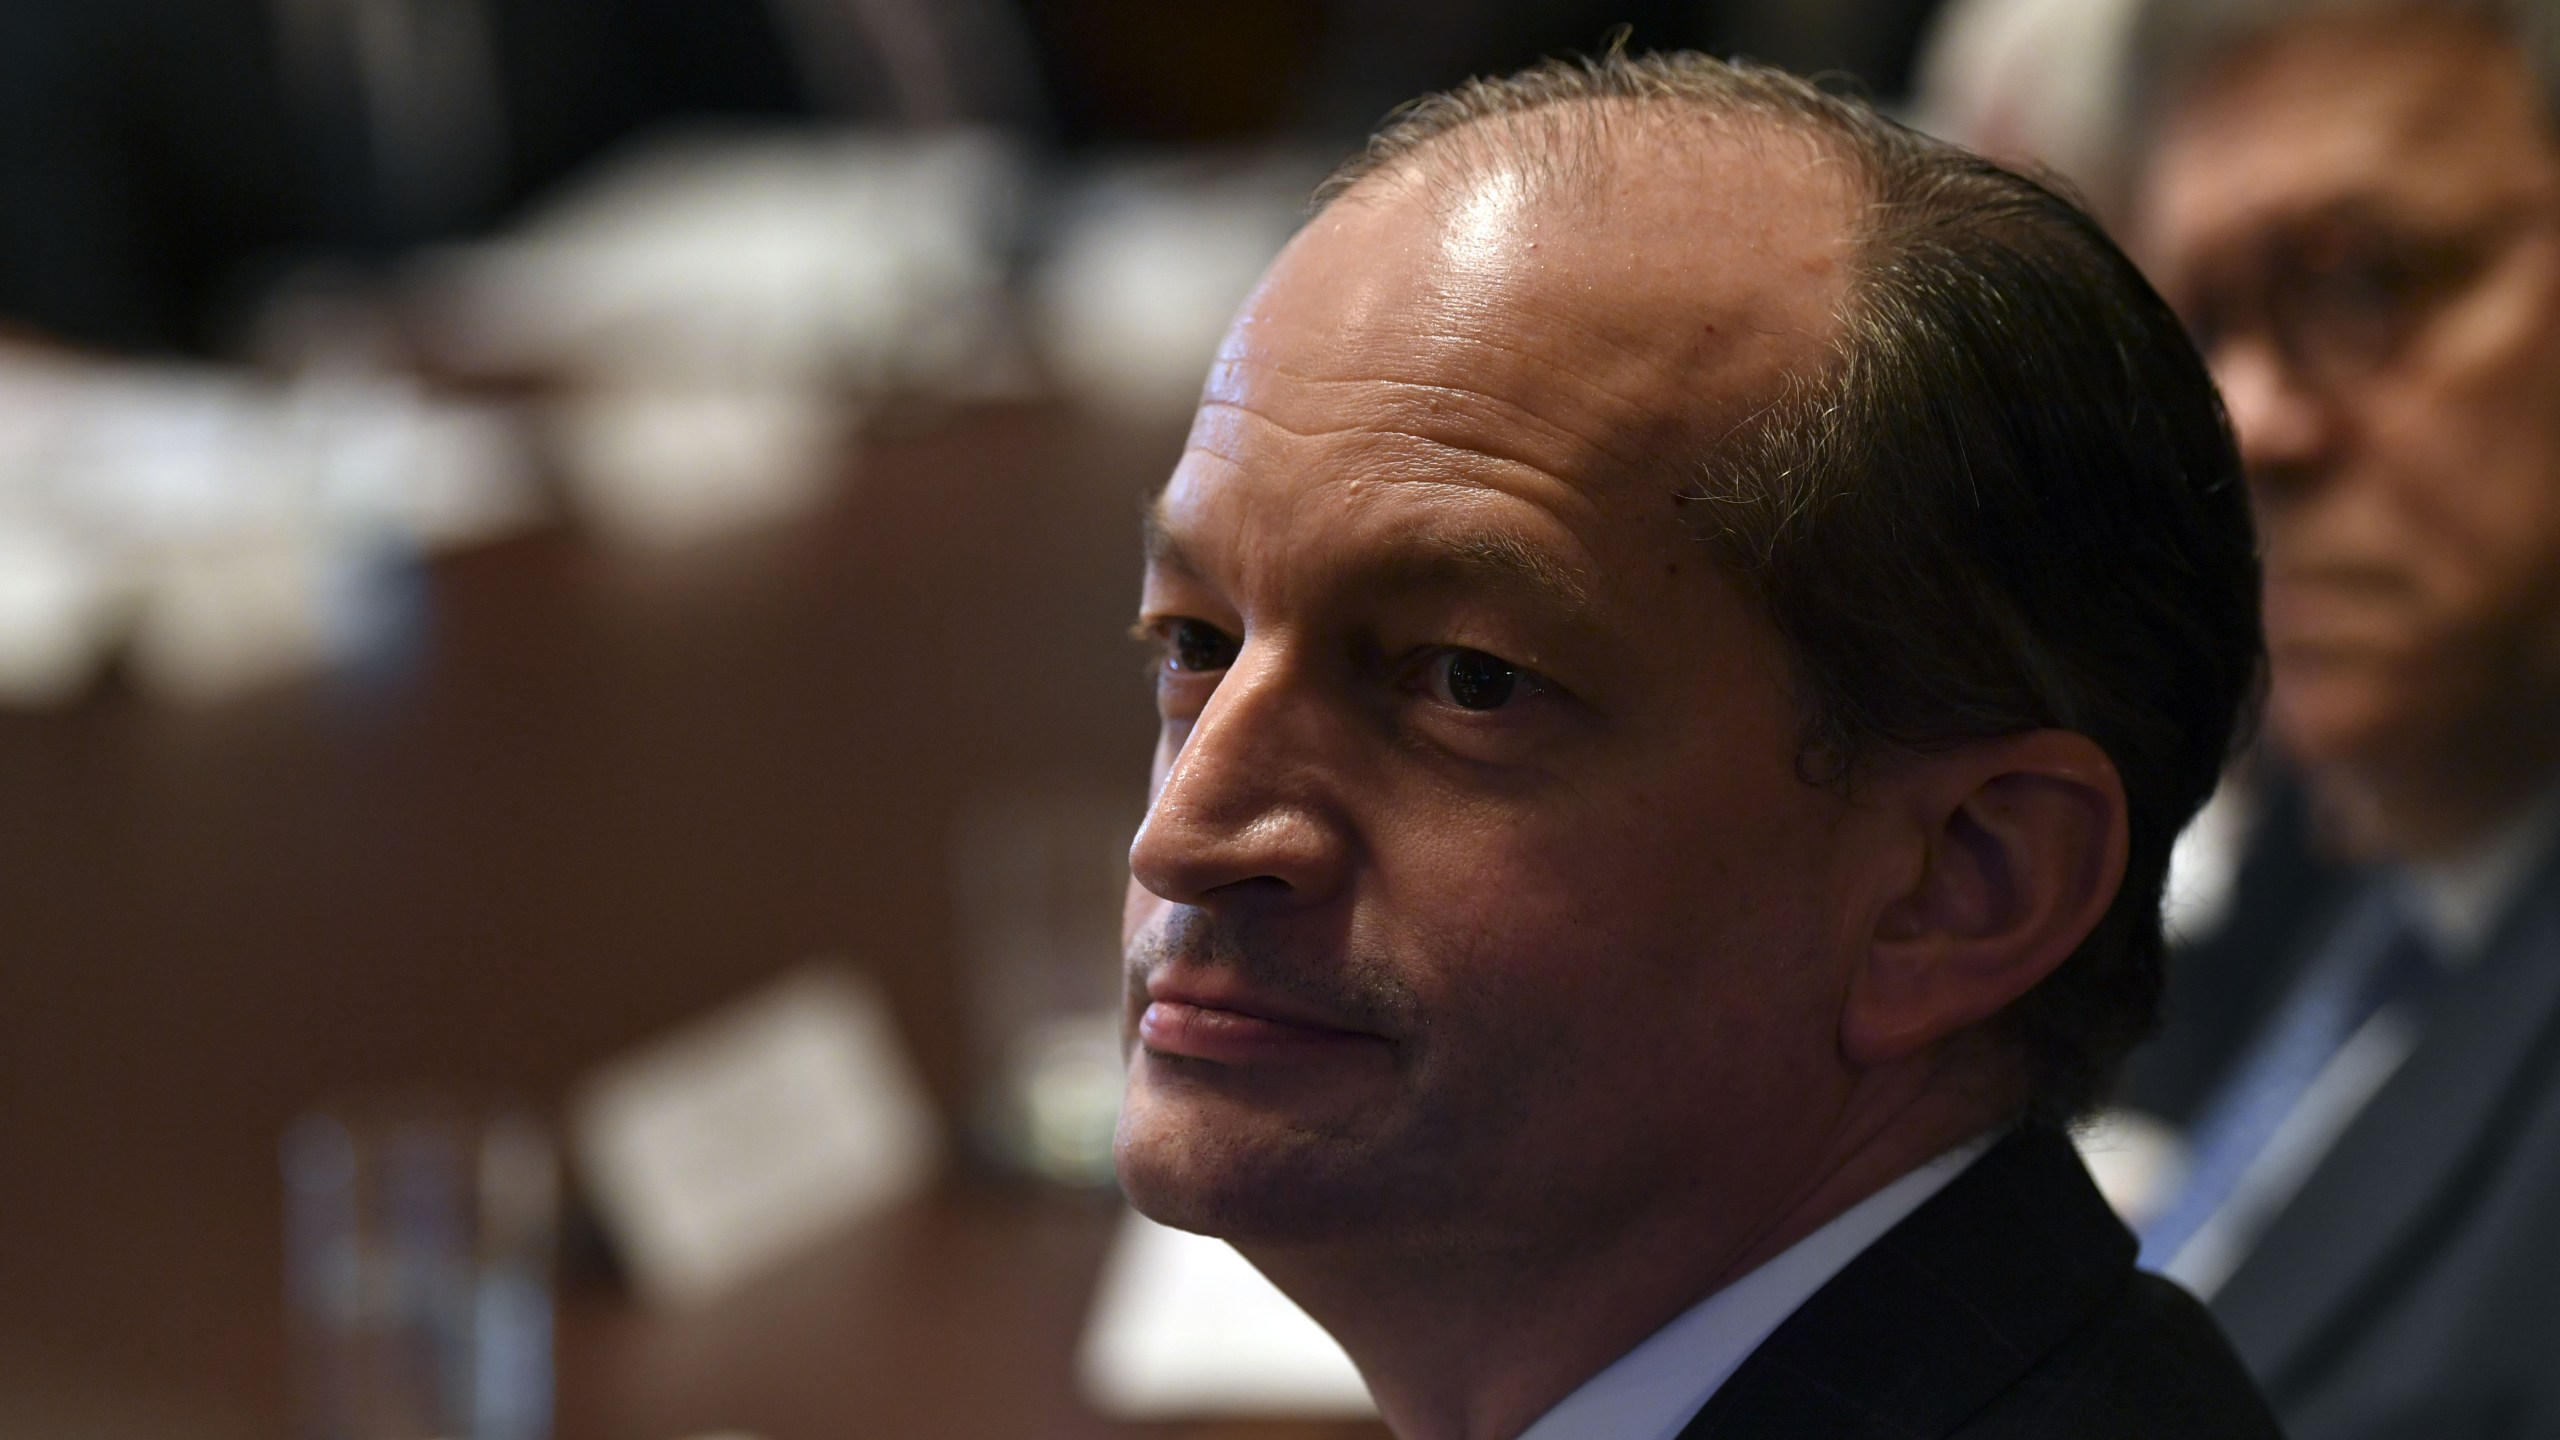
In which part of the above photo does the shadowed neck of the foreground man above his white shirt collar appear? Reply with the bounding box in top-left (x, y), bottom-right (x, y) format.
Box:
top-left (1244, 1089), bottom-right (1997, 1440)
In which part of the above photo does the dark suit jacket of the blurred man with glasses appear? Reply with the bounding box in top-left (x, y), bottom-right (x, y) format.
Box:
top-left (2160, 814), bottom-right (2560, 1440)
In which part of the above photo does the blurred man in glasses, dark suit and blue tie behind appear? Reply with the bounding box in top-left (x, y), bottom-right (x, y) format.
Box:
top-left (2135, 0), bottom-right (2560, 1440)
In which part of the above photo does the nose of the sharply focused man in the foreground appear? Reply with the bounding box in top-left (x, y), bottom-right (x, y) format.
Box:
top-left (1129, 643), bottom-right (1352, 907)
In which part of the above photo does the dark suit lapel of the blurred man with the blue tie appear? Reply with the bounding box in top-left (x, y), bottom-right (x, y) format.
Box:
top-left (2214, 856), bottom-right (2560, 1407)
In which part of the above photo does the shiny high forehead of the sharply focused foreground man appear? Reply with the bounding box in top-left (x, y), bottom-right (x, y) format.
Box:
top-left (1162, 115), bottom-right (1856, 566)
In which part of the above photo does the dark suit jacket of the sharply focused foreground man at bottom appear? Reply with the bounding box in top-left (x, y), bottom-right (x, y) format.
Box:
top-left (1679, 1130), bottom-right (2278, 1440)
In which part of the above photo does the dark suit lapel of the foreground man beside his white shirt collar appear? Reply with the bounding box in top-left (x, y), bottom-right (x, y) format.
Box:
top-left (1679, 1130), bottom-right (2132, 1440)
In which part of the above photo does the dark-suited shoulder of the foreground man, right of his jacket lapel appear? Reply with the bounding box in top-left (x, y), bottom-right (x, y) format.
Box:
top-left (1956, 1273), bottom-right (2281, 1440)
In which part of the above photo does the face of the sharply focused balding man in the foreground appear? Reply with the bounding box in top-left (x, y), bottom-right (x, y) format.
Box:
top-left (1119, 141), bottom-right (1848, 1248)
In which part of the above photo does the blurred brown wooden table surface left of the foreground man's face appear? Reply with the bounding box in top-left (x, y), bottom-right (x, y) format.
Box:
top-left (0, 399), bottom-right (1377, 1440)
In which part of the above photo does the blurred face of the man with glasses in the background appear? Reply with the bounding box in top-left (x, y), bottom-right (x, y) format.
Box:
top-left (2143, 15), bottom-right (2560, 771)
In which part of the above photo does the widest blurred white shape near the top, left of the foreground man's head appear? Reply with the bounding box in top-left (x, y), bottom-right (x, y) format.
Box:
top-left (420, 131), bottom-right (1021, 395)
